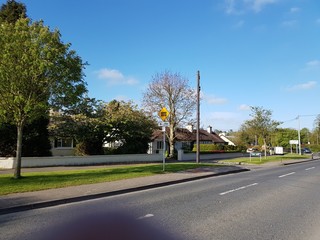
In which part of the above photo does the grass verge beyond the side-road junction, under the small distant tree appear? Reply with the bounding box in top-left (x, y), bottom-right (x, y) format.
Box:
top-left (221, 154), bottom-right (311, 165)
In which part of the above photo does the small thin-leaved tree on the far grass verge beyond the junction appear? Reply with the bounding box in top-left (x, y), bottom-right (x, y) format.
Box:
top-left (243, 107), bottom-right (281, 157)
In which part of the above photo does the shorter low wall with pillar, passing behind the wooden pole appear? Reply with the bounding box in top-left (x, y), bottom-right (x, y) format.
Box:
top-left (178, 150), bottom-right (246, 161)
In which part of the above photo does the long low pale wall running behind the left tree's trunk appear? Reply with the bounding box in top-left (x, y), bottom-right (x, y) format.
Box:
top-left (0, 154), bottom-right (162, 169)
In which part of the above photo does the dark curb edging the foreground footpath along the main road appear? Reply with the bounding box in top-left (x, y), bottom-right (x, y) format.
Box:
top-left (0, 168), bottom-right (250, 215)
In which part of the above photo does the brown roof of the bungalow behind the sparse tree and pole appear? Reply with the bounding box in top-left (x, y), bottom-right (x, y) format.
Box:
top-left (151, 128), bottom-right (226, 144)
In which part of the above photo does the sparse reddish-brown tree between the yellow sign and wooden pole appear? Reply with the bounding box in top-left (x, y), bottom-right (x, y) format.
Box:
top-left (143, 71), bottom-right (197, 157)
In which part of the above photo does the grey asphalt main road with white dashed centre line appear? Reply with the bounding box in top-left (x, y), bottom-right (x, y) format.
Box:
top-left (0, 161), bottom-right (320, 240)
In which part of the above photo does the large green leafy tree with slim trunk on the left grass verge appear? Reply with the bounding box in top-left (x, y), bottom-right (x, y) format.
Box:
top-left (0, 18), bottom-right (86, 178)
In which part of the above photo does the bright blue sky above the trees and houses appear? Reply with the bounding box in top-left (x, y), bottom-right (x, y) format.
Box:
top-left (5, 0), bottom-right (320, 130)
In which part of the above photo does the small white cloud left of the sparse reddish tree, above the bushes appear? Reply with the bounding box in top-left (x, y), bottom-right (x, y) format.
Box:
top-left (95, 68), bottom-right (138, 85)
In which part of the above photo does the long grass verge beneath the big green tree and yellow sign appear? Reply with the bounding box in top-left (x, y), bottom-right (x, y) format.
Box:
top-left (0, 163), bottom-right (218, 196)
